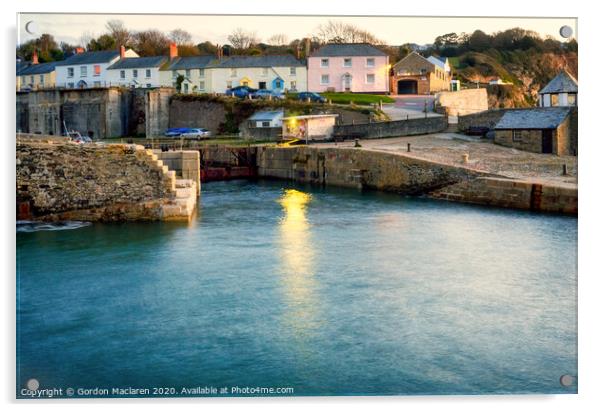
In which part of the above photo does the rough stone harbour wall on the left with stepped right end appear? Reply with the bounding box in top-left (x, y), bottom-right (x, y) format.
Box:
top-left (16, 139), bottom-right (196, 221)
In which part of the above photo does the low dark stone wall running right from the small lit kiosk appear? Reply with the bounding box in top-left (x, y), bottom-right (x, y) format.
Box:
top-left (334, 116), bottom-right (447, 139)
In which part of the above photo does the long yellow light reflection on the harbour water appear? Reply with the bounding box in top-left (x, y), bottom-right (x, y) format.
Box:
top-left (279, 189), bottom-right (319, 336)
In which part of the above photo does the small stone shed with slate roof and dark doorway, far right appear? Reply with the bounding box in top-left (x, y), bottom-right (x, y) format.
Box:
top-left (494, 107), bottom-right (577, 155)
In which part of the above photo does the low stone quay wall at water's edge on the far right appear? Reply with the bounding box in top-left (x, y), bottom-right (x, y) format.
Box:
top-left (430, 177), bottom-right (578, 214)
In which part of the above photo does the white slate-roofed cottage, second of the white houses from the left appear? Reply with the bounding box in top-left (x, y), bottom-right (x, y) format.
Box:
top-left (107, 56), bottom-right (167, 88)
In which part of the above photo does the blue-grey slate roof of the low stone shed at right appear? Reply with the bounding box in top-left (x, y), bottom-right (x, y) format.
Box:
top-left (494, 107), bottom-right (571, 130)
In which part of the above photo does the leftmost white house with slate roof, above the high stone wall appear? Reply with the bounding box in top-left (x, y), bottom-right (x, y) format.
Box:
top-left (56, 46), bottom-right (138, 89)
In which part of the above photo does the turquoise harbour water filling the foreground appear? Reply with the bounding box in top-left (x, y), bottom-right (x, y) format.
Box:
top-left (17, 181), bottom-right (577, 397)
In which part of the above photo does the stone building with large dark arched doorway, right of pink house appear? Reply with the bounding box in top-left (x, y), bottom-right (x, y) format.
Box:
top-left (391, 52), bottom-right (451, 94)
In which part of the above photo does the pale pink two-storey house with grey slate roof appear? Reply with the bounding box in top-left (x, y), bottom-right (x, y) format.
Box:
top-left (307, 43), bottom-right (390, 93)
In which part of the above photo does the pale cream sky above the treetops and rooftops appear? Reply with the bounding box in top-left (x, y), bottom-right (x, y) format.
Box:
top-left (18, 13), bottom-right (577, 45)
